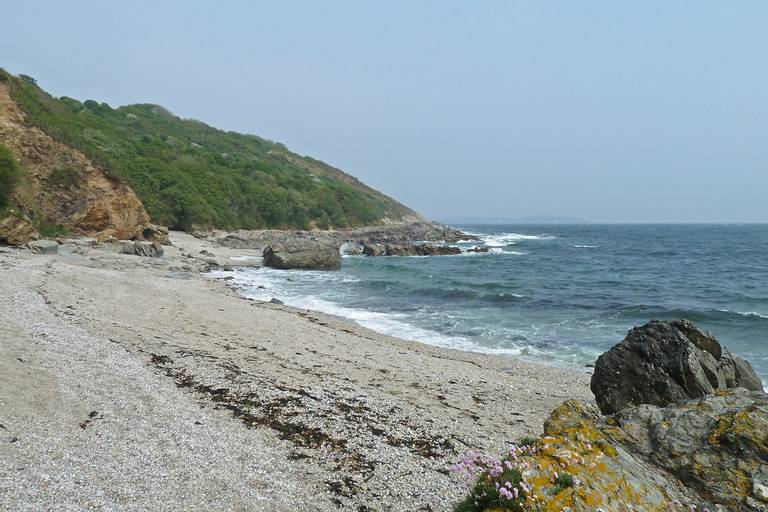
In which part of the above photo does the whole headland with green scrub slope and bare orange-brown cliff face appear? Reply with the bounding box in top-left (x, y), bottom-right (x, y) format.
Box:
top-left (0, 69), bottom-right (423, 234)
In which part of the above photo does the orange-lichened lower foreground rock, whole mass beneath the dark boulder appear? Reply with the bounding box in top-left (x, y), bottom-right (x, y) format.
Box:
top-left (527, 388), bottom-right (768, 512)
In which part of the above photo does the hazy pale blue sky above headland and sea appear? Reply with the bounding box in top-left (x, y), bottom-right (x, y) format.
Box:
top-left (0, 0), bottom-right (768, 222)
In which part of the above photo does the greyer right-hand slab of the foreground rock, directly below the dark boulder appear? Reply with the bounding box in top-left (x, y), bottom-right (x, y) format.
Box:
top-left (613, 388), bottom-right (768, 511)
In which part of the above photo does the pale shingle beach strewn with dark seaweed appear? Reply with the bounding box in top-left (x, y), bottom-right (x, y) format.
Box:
top-left (0, 233), bottom-right (591, 512)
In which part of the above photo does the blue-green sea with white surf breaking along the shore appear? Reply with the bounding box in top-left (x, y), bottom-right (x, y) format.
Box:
top-left (213, 224), bottom-right (768, 381)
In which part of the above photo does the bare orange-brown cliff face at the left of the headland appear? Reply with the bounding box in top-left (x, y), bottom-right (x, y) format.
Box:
top-left (0, 81), bottom-right (149, 239)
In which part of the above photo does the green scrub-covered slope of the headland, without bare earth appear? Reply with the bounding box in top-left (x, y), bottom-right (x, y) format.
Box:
top-left (0, 69), bottom-right (416, 230)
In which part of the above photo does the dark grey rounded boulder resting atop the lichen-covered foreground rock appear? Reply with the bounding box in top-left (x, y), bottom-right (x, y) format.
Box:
top-left (590, 320), bottom-right (763, 414)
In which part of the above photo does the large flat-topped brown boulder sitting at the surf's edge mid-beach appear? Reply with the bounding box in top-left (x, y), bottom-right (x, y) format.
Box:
top-left (263, 240), bottom-right (341, 270)
